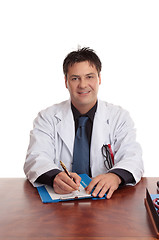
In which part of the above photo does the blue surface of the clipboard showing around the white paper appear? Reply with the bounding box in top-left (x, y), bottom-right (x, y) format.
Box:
top-left (37, 174), bottom-right (106, 203)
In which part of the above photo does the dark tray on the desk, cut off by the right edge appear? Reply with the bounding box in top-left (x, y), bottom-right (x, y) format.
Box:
top-left (145, 189), bottom-right (159, 238)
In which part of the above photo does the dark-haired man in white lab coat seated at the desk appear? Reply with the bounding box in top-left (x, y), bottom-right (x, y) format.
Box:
top-left (24, 48), bottom-right (143, 199)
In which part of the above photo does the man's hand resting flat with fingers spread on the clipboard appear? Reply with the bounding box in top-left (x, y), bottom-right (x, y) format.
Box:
top-left (86, 173), bottom-right (121, 199)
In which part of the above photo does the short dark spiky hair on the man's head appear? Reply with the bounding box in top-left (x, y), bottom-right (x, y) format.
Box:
top-left (63, 47), bottom-right (102, 77)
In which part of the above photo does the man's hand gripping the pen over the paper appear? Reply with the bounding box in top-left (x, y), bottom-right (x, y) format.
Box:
top-left (53, 172), bottom-right (81, 194)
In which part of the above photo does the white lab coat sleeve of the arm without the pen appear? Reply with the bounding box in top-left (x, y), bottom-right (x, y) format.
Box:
top-left (109, 110), bottom-right (144, 184)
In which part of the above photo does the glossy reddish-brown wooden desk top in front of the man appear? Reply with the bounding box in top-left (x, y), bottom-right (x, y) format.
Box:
top-left (0, 178), bottom-right (158, 240)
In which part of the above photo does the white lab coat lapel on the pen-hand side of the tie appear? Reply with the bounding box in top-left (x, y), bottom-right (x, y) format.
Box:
top-left (55, 101), bottom-right (75, 156)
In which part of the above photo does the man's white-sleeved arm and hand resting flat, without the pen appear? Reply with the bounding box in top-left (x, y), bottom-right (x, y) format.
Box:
top-left (87, 107), bottom-right (143, 198)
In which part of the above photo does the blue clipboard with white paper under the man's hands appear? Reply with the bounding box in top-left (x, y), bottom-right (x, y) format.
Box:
top-left (37, 174), bottom-right (106, 203)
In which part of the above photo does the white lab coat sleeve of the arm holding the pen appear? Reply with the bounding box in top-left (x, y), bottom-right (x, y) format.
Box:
top-left (24, 111), bottom-right (58, 185)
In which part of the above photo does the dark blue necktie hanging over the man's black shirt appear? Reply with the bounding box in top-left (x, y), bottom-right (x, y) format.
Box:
top-left (72, 117), bottom-right (89, 175)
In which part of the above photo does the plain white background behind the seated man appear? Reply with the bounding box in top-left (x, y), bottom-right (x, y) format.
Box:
top-left (0, 0), bottom-right (159, 177)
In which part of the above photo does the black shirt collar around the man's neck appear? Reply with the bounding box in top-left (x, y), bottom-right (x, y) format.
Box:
top-left (71, 101), bottom-right (98, 122)
